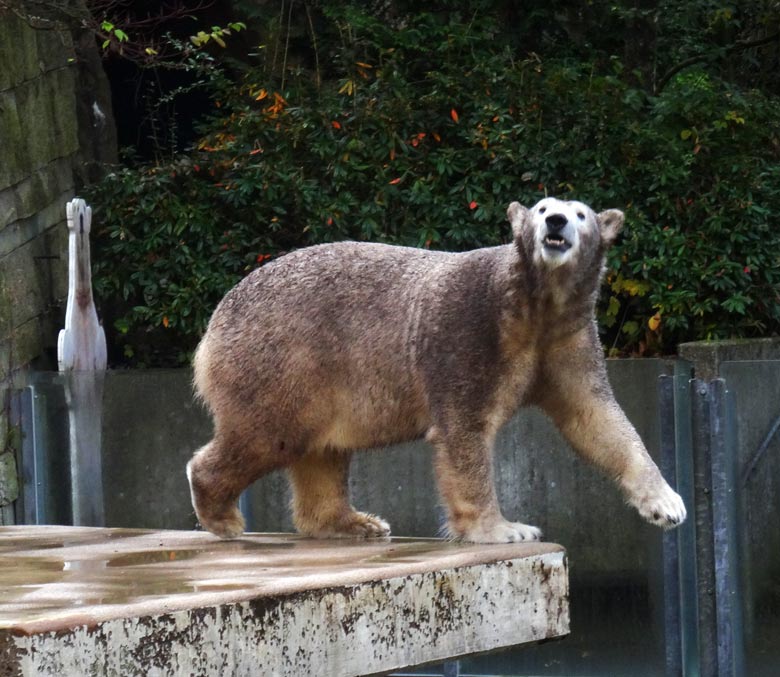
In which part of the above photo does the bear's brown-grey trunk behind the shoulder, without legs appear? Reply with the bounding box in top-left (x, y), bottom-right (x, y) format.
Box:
top-left (195, 242), bottom-right (488, 446)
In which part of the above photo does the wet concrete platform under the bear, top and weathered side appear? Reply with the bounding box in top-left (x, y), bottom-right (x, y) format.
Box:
top-left (0, 526), bottom-right (568, 674)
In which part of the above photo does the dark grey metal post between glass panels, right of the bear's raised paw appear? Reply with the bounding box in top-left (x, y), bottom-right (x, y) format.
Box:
top-left (691, 379), bottom-right (718, 677)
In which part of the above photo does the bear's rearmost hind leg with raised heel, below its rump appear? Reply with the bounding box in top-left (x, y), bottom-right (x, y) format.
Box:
top-left (187, 435), bottom-right (285, 538)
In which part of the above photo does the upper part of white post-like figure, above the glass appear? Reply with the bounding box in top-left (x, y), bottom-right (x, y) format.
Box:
top-left (57, 198), bottom-right (106, 371)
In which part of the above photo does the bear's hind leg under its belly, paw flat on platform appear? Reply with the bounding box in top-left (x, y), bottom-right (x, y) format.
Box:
top-left (289, 451), bottom-right (390, 538)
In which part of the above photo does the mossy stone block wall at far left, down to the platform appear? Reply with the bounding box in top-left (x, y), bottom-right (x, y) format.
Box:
top-left (0, 0), bottom-right (117, 524)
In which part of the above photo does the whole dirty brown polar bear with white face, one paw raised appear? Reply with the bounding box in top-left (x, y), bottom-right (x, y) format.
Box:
top-left (187, 198), bottom-right (685, 542)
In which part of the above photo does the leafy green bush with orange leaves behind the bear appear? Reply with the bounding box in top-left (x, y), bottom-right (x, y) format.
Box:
top-left (89, 7), bottom-right (780, 364)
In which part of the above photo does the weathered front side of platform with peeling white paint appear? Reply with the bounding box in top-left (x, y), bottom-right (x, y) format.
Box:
top-left (0, 552), bottom-right (569, 677)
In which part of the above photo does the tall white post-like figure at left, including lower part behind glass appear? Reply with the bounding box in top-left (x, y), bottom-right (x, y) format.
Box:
top-left (57, 199), bottom-right (106, 527)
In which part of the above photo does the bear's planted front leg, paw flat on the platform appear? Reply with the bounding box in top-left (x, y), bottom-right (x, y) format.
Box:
top-left (426, 426), bottom-right (542, 543)
